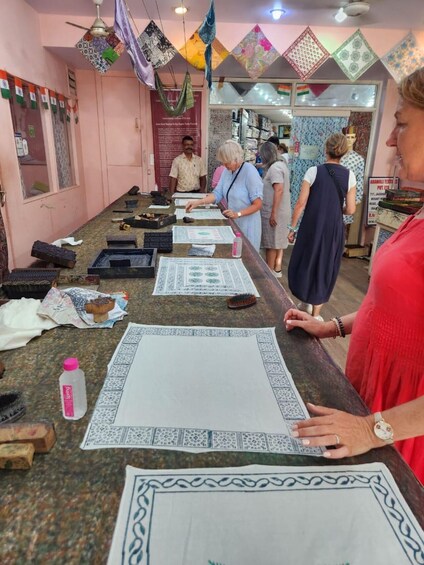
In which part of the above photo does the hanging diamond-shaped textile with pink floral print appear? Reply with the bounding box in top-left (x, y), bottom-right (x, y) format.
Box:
top-left (232, 25), bottom-right (280, 79)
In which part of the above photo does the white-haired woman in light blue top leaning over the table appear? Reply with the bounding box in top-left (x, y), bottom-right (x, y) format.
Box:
top-left (186, 139), bottom-right (263, 251)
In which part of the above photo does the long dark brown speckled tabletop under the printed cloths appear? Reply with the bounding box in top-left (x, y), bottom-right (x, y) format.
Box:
top-left (0, 195), bottom-right (424, 565)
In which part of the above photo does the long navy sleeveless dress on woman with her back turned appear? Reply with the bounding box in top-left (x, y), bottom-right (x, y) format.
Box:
top-left (288, 163), bottom-right (349, 304)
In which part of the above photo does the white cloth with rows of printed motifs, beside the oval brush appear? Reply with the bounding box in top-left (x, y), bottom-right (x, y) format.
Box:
top-left (153, 258), bottom-right (259, 296)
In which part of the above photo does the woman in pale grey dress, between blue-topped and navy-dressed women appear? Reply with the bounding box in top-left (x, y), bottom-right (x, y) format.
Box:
top-left (259, 141), bottom-right (291, 277)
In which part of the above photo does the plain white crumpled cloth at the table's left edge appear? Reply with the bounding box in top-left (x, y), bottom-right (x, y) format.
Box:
top-left (0, 298), bottom-right (59, 351)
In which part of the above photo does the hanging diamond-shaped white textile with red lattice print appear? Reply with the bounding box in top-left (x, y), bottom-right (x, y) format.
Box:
top-left (283, 27), bottom-right (330, 79)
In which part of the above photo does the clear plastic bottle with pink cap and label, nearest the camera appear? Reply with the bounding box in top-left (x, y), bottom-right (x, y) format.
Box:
top-left (59, 357), bottom-right (87, 420)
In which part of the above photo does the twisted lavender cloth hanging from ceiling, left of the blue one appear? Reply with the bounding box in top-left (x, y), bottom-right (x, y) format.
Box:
top-left (114, 0), bottom-right (155, 88)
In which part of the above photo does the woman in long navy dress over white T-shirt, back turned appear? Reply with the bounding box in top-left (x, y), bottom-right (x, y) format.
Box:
top-left (288, 133), bottom-right (356, 319)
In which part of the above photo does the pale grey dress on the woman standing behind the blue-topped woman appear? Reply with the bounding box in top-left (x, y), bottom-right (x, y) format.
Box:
top-left (261, 161), bottom-right (291, 249)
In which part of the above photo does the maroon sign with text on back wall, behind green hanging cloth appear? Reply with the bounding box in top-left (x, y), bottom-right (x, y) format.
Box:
top-left (150, 90), bottom-right (202, 190)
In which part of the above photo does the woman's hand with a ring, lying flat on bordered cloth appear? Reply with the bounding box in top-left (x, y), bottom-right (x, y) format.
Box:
top-left (292, 402), bottom-right (374, 459)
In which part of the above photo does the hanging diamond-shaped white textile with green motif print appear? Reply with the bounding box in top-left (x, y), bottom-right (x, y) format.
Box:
top-left (333, 29), bottom-right (378, 80)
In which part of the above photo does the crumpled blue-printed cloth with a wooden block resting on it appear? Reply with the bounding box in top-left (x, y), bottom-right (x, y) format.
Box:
top-left (38, 287), bottom-right (128, 329)
